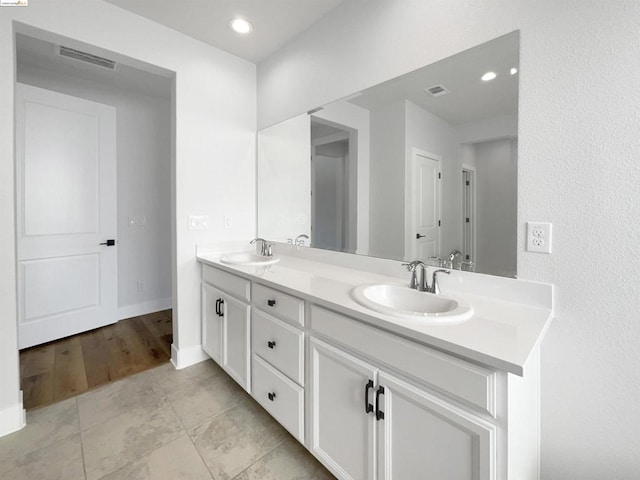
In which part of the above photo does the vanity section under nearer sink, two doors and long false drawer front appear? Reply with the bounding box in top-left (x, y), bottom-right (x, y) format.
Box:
top-left (310, 305), bottom-right (498, 480)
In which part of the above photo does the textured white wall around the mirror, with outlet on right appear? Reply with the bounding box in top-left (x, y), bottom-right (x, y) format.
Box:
top-left (258, 0), bottom-right (640, 480)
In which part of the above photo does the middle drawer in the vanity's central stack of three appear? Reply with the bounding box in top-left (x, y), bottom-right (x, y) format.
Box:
top-left (251, 308), bottom-right (304, 385)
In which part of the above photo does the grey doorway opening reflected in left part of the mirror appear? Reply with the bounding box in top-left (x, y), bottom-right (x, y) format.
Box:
top-left (311, 118), bottom-right (350, 251)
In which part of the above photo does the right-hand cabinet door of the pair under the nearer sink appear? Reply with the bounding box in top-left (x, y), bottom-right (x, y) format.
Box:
top-left (377, 372), bottom-right (496, 480)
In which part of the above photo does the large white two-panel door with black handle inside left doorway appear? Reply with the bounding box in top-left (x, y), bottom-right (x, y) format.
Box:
top-left (16, 84), bottom-right (117, 348)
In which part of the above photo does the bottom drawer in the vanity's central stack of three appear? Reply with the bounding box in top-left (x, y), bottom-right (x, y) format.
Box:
top-left (252, 355), bottom-right (304, 442)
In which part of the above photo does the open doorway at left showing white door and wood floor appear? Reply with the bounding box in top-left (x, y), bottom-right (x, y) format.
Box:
top-left (15, 30), bottom-right (175, 406)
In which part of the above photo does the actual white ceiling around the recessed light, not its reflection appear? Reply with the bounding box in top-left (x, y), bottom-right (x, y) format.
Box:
top-left (106, 0), bottom-right (344, 63)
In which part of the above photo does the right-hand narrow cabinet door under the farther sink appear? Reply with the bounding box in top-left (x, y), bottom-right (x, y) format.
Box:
top-left (222, 294), bottom-right (251, 392)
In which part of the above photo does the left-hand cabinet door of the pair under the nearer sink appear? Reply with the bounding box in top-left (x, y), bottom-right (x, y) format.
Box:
top-left (310, 339), bottom-right (376, 480)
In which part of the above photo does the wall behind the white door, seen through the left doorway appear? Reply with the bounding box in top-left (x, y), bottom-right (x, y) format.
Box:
top-left (17, 63), bottom-right (171, 319)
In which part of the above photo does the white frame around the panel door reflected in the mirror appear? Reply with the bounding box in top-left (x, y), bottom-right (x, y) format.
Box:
top-left (404, 147), bottom-right (442, 261)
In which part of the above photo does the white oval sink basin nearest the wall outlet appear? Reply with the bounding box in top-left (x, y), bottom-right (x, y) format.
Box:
top-left (351, 283), bottom-right (473, 325)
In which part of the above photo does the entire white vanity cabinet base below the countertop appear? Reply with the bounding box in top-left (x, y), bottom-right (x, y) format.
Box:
top-left (202, 258), bottom-right (540, 480)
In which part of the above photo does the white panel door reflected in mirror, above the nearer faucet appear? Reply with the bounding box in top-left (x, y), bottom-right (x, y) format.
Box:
top-left (416, 152), bottom-right (441, 261)
